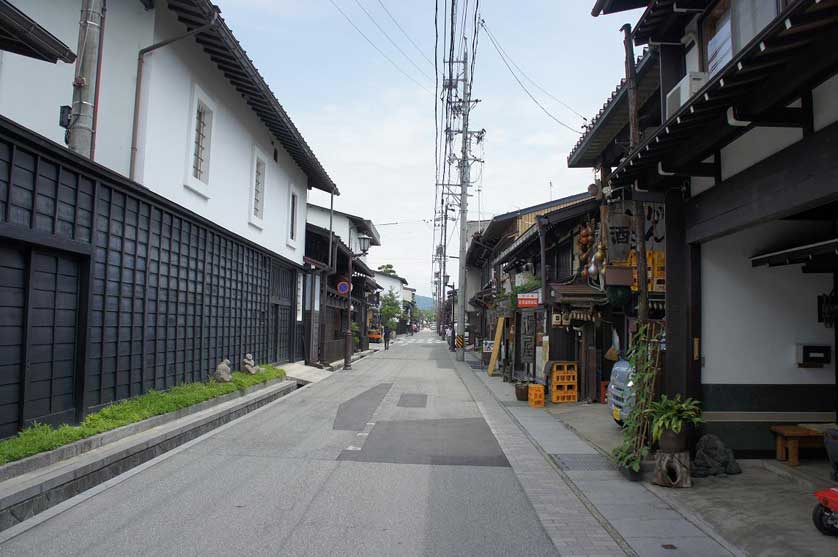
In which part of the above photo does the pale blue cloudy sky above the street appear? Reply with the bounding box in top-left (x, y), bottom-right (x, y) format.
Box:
top-left (216, 0), bottom-right (640, 295)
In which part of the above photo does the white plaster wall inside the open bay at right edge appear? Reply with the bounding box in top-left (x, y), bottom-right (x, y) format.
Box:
top-left (701, 221), bottom-right (835, 384)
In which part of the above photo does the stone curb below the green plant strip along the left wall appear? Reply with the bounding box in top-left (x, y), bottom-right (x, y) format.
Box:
top-left (0, 380), bottom-right (298, 531)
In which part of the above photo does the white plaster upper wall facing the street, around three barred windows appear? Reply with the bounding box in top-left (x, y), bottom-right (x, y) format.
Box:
top-left (137, 3), bottom-right (307, 263)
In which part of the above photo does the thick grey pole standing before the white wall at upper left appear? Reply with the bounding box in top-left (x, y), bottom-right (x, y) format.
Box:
top-left (67, 0), bottom-right (105, 158)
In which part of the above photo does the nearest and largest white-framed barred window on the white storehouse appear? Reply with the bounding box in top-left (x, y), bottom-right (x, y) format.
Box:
top-left (184, 81), bottom-right (216, 198)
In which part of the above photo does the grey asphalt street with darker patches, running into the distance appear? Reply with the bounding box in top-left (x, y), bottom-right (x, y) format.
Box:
top-left (0, 332), bottom-right (556, 556)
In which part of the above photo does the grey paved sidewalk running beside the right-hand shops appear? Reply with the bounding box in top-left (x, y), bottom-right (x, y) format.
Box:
top-left (468, 354), bottom-right (743, 557)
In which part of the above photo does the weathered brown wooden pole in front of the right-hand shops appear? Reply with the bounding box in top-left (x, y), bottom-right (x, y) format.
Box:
top-left (621, 23), bottom-right (649, 322)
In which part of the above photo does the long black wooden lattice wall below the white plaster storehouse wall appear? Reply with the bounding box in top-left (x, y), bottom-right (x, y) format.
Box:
top-left (0, 117), bottom-right (297, 430)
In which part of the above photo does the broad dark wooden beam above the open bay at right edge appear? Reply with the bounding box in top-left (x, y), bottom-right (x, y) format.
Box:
top-left (685, 123), bottom-right (838, 243)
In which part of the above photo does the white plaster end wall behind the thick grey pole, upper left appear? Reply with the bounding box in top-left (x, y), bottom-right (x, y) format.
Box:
top-left (0, 0), bottom-right (154, 175)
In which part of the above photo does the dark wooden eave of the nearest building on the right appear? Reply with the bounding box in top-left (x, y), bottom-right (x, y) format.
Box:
top-left (610, 0), bottom-right (838, 188)
